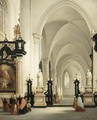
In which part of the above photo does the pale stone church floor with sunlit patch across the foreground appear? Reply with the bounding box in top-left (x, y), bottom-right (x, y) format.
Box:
top-left (0, 107), bottom-right (97, 120)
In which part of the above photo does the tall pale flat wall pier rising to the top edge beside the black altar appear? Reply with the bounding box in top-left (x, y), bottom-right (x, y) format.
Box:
top-left (20, 0), bottom-right (33, 93)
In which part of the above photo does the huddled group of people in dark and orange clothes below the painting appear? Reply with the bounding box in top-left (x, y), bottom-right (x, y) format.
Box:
top-left (2, 96), bottom-right (31, 115)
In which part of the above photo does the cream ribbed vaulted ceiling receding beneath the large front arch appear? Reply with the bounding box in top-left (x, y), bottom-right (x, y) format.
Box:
top-left (43, 6), bottom-right (92, 79)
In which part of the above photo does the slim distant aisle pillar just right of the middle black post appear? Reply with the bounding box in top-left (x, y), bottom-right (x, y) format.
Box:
top-left (51, 69), bottom-right (57, 94)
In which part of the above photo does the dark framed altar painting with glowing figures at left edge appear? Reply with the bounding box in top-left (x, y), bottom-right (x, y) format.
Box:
top-left (0, 63), bottom-right (16, 92)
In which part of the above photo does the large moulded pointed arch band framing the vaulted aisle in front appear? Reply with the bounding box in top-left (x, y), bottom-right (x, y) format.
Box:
top-left (36, 0), bottom-right (94, 35)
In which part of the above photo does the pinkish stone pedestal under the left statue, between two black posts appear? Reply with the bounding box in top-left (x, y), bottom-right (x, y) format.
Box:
top-left (34, 92), bottom-right (47, 107)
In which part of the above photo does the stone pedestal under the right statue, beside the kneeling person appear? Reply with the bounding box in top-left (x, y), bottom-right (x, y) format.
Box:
top-left (83, 87), bottom-right (95, 107)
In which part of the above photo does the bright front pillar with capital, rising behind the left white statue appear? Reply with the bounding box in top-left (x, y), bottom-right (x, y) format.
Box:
top-left (33, 33), bottom-right (42, 86)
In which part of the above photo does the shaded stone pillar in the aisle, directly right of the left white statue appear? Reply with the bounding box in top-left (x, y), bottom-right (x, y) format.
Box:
top-left (42, 58), bottom-right (49, 87)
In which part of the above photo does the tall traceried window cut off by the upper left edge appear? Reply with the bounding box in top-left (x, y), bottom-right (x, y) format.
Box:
top-left (0, 0), bottom-right (8, 32)
